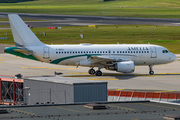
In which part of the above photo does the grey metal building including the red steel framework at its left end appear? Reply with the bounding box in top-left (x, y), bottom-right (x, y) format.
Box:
top-left (0, 76), bottom-right (108, 105)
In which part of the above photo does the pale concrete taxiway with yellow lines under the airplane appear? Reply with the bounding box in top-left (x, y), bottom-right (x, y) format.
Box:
top-left (0, 53), bottom-right (180, 92)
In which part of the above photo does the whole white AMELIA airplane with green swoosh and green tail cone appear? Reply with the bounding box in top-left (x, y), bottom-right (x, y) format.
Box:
top-left (4, 14), bottom-right (177, 76)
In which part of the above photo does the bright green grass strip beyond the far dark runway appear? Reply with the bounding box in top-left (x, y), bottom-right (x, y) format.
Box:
top-left (0, 0), bottom-right (180, 18)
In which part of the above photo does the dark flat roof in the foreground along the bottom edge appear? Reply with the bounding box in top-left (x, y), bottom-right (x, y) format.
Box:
top-left (0, 101), bottom-right (180, 120)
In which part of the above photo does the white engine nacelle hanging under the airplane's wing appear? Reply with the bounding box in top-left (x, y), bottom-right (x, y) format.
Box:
top-left (106, 61), bottom-right (135, 73)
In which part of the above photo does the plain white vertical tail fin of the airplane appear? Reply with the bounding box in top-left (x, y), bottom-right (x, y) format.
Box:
top-left (8, 14), bottom-right (44, 47)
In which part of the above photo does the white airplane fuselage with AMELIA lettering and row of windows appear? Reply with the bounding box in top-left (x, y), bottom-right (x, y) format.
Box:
top-left (30, 44), bottom-right (176, 67)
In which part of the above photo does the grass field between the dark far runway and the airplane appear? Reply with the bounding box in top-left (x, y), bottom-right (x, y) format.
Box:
top-left (0, 25), bottom-right (180, 53)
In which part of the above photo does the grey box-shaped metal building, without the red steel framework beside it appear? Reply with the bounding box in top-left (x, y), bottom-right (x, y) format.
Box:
top-left (24, 76), bottom-right (107, 104)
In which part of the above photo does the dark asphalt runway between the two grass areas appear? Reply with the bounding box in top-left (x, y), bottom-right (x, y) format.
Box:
top-left (0, 12), bottom-right (180, 27)
